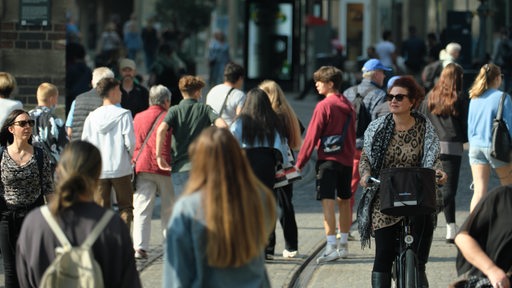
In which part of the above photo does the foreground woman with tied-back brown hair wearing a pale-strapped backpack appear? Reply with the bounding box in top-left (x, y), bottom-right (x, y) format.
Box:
top-left (16, 140), bottom-right (141, 287)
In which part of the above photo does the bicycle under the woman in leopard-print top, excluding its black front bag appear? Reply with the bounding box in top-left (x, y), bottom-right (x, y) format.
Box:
top-left (367, 173), bottom-right (434, 288)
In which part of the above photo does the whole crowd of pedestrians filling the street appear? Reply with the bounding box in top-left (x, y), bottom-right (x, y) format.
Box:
top-left (0, 16), bottom-right (512, 288)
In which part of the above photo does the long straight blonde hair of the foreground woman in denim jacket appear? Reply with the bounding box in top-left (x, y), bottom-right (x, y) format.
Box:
top-left (184, 127), bottom-right (276, 268)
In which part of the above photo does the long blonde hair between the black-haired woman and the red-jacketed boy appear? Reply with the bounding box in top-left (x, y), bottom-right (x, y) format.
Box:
top-left (259, 80), bottom-right (302, 150)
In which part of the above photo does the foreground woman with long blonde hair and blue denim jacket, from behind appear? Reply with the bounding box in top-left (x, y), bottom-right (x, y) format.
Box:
top-left (163, 127), bottom-right (276, 287)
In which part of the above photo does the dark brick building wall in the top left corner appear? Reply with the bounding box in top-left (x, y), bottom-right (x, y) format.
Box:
top-left (0, 0), bottom-right (66, 104)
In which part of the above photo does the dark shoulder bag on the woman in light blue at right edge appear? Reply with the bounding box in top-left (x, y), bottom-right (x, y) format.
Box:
top-left (491, 92), bottom-right (512, 163)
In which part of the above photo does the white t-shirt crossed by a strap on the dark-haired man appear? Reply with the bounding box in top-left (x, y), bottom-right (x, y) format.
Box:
top-left (206, 84), bottom-right (245, 126)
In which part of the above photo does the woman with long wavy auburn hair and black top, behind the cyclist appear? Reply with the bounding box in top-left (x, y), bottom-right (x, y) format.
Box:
top-left (420, 63), bottom-right (469, 243)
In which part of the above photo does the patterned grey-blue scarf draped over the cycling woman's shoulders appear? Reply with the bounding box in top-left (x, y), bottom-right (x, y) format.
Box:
top-left (357, 110), bottom-right (440, 248)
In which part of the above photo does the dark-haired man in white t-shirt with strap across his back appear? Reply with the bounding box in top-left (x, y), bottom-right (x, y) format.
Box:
top-left (206, 62), bottom-right (245, 126)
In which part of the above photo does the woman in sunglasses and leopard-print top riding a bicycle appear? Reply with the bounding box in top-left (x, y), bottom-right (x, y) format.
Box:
top-left (357, 76), bottom-right (447, 287)
